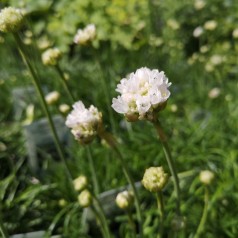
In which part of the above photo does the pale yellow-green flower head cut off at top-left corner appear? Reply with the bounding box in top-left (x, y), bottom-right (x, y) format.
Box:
top-left (0, 7), bottom-right (24, 32)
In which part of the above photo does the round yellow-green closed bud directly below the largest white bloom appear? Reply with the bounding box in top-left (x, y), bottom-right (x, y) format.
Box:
top-left (142, 167), bottom-right (169, 192)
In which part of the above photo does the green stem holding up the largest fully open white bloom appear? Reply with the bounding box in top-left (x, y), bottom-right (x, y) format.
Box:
top-left (153, 120), bottom-right (180, 215)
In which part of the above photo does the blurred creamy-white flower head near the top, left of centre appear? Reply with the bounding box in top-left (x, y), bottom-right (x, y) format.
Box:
top-left (74, 24), bottom-right (96, 45)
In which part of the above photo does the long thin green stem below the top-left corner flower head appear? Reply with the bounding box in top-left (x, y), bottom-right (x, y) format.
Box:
top-left (13, 33), bottom-right (72, 178)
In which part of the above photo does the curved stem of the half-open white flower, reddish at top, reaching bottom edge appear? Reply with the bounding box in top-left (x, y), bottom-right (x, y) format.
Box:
top-left (99, 129), bottom-right (143, 237)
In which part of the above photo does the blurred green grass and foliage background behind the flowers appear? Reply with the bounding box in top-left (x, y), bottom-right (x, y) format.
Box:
top-left (0, 0), bottom-right (238, 238)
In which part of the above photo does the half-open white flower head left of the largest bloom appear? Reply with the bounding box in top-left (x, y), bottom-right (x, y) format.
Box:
top-left (65, 101), bottom-right (102, 144)
